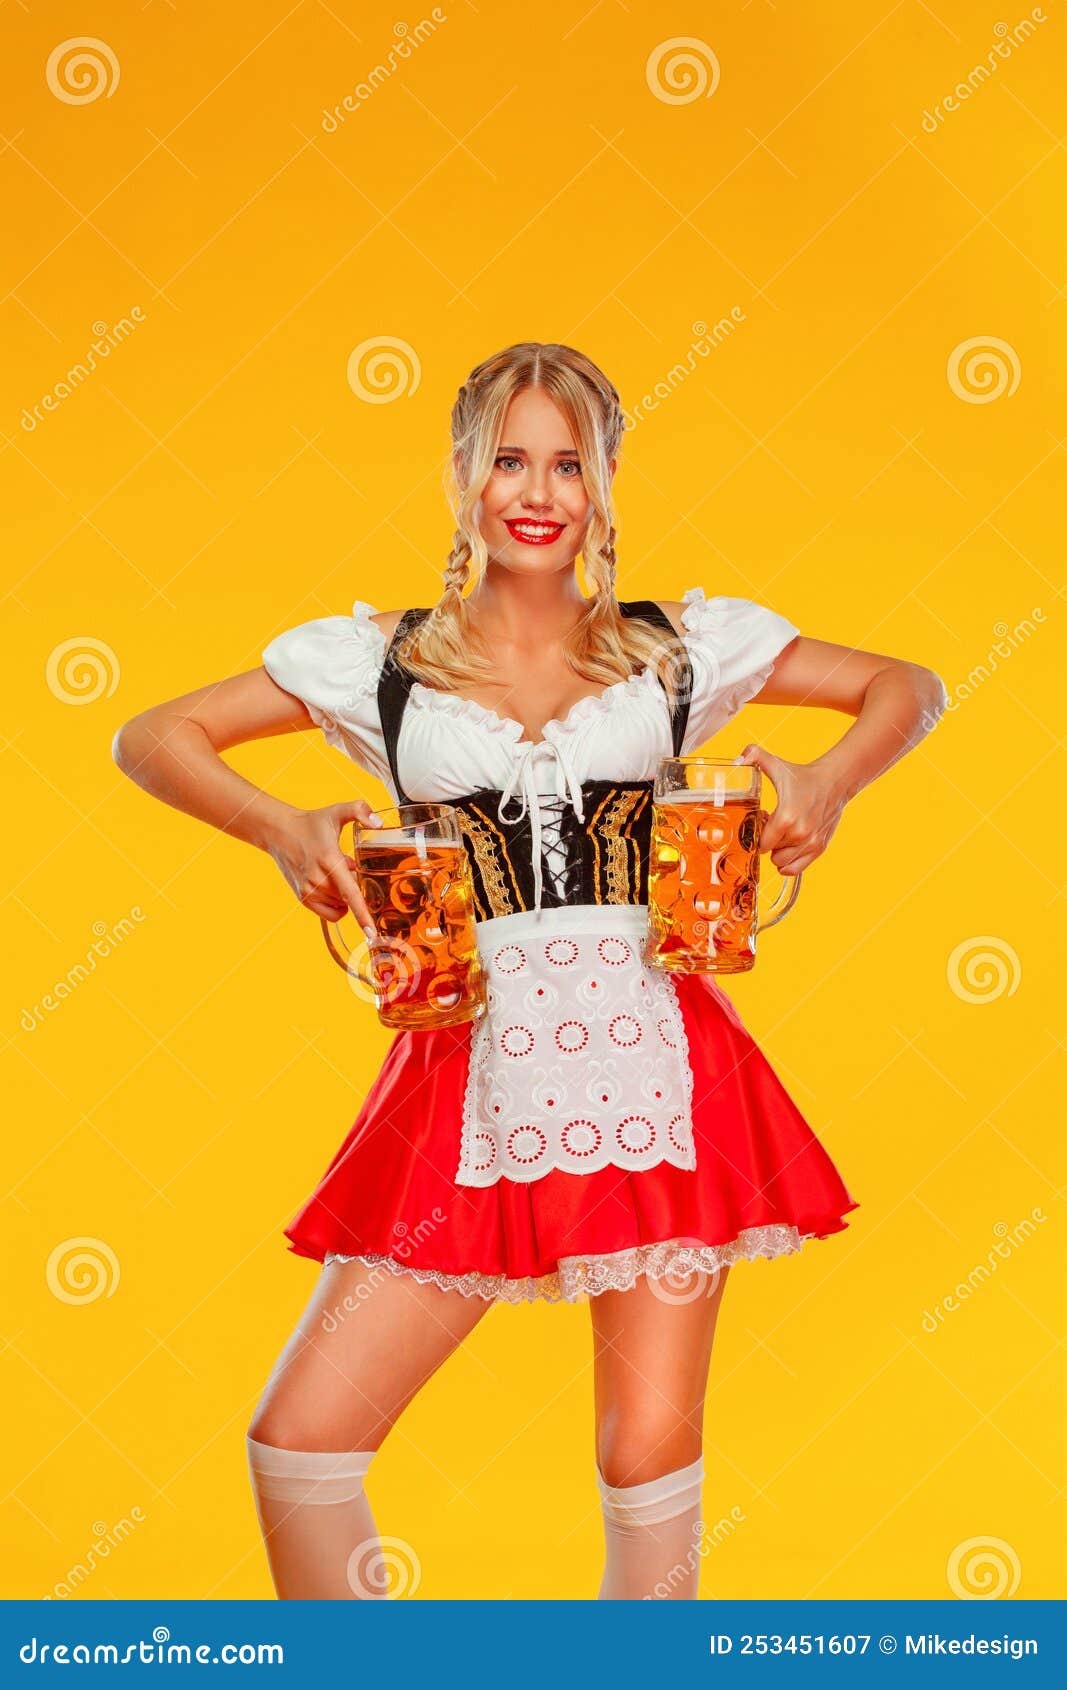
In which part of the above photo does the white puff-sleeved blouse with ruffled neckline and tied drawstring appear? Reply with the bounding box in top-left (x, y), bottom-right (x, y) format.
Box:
top-left (262, 586), bottom-right (800, 909)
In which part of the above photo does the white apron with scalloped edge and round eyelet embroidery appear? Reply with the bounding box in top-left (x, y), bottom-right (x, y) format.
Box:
top-left (457, 906), bottom-right (697, 1186)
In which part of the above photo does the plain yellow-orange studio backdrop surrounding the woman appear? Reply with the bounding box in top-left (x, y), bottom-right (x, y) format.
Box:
top-left (0, 0), bottom-right (1067, 1599)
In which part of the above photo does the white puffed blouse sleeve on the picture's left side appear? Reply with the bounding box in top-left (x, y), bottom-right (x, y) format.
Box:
top-left (262, 598), bottom-right (391, 784)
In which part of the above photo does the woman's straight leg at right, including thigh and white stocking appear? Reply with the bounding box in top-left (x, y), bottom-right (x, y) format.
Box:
top-left (590, 1268), bottom-right (729, 1599)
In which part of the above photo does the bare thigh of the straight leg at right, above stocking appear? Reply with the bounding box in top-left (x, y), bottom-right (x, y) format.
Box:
top-left (590, 1268), bottom-right (729, 1486)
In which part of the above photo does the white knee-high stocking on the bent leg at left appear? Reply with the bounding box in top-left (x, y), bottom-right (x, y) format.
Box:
top-left (245, 1437), bottom-right (389, 1602)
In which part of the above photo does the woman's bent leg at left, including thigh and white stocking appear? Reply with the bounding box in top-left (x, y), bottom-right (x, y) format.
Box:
top-left (249, 1262), bottom-right (492, 1600)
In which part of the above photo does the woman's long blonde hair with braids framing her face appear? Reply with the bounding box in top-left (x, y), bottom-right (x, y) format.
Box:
top-left (396, 341), bottom-right (683, 706)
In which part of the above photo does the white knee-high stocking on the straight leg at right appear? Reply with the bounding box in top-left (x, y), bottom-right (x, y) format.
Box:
top-left (597, 1455), bottom-right (703, 1600)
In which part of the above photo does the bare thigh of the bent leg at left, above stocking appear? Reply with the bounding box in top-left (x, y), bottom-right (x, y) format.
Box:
top-left (249, 1261), bottom-right (492, 1450)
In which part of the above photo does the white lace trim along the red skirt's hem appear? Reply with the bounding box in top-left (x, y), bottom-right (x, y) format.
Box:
top-left (323, 1225), bottom-right (817, 1303)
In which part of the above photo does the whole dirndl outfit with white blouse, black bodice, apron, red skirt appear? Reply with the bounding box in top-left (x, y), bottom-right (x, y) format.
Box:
top-left (262, 588), bottom-right (859, 1303)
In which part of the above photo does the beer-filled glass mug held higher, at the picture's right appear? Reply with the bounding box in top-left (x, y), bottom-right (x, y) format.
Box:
top-left (643, 757), bottom-right (800, 973)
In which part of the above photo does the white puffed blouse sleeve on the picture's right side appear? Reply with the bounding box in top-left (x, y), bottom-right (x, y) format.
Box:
top-left (681, 586), bottom-right (800, 754)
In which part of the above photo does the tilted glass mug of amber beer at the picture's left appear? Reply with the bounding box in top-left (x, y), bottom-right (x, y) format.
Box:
top-left (321, 804), bottom-right (485, 1029)
